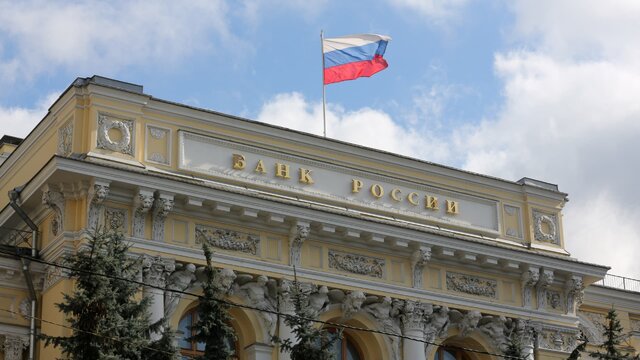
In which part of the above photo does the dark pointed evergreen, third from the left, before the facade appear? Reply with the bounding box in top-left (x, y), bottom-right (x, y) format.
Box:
top-left (273, 269), bottom-right (342, 360)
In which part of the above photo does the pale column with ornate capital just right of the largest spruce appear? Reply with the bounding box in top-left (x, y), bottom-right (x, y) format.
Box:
top-left (142, 256), bottom-right (175, 340)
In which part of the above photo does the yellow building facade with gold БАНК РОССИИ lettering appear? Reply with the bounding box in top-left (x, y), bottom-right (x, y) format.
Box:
top-left (0, 76), bottom-right (640, 360)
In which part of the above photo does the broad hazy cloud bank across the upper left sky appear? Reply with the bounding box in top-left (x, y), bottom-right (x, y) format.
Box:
top-left (0, 0), bottom-right (238, 83)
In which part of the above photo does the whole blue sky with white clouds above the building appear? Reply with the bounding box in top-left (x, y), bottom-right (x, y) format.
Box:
top-left (0, 0), bottom-right (640, 279)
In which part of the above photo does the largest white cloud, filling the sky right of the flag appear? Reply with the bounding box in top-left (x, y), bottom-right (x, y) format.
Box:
top-left (453, 0), bottom-right (640, 278)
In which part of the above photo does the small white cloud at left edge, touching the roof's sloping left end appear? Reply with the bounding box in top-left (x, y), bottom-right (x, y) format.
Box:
top-left (0, 93), bottom-right (60, 138)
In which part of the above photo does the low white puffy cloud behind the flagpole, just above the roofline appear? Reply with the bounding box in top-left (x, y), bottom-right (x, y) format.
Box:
top-left (257, 93), bottom-right (449, 161)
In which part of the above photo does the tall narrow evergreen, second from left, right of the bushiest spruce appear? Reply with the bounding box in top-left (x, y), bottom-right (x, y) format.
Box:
top-left (191, 242), bottom-right (236, 360)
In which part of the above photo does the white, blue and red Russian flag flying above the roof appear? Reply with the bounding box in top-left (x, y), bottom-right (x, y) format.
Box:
top-left (322, 34), bottom-right (391, 85)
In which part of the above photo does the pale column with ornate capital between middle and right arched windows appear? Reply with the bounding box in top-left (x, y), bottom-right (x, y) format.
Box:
top-left (402, 300), bottom-right (426, 360)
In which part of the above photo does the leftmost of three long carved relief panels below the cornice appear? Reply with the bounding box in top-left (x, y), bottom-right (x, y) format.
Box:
top-left (196, 224), bottom-right (260, 255)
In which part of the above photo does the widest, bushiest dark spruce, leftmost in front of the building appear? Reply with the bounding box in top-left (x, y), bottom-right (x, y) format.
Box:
top-left (43, 230), bottom-right (176, 360)
